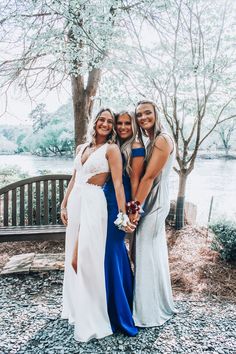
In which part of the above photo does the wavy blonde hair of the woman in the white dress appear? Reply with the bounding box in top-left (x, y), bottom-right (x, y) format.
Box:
top-left (86, 108), bottom-right (116, 145)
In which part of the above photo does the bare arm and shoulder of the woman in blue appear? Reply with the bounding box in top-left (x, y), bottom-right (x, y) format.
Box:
top-left (130, 142), bottom-right (144, 200)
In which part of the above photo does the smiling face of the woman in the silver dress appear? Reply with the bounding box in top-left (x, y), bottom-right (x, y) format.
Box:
top-left (136, 103), bottom-right (156, 133)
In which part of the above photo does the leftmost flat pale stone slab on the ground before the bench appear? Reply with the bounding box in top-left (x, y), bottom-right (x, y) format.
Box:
top-left (1, 253), bottom-right (35, 274)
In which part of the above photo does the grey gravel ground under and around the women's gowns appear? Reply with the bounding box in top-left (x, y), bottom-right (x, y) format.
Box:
top-left (0, 272), bottom-right (236, 354)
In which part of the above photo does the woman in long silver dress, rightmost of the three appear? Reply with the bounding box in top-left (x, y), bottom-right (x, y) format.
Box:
top-left (130, 101), bottom-right (175, 327)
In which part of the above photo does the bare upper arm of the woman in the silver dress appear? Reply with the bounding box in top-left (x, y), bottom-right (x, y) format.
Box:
top-left (135, 136), bottom-right (173, 204)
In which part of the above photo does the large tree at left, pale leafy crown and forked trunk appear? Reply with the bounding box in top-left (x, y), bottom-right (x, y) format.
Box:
top-left (0, 0), bottom-right (128, 144)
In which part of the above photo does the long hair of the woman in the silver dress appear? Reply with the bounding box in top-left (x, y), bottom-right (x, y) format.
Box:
top-left (135, 100), bottom-right (164, 161)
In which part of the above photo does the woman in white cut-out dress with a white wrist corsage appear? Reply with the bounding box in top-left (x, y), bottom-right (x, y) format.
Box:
top-left (61, 109), bottom-right (133, 342)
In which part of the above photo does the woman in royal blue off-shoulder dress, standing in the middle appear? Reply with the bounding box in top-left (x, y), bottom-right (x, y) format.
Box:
top-left (104, 112), bottom-right (145, 336)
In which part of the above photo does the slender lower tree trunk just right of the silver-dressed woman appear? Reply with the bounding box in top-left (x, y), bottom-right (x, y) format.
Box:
top-left (175, 172), bottom-right (188, 230)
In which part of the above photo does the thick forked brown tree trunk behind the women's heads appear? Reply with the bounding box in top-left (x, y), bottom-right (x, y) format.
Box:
top-left (71, 69), bottom-right (101, 147)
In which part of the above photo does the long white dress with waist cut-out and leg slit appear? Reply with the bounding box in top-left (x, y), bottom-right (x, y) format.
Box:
top-left (62, 144), bottom-right (112, 342)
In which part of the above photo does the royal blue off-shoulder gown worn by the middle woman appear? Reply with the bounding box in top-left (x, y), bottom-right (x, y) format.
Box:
top-left (103, 148), bottom-right (145, 336)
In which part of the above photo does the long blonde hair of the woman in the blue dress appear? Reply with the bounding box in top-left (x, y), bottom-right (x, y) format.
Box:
top-left (115, 111), bottom-right (138, 175)
